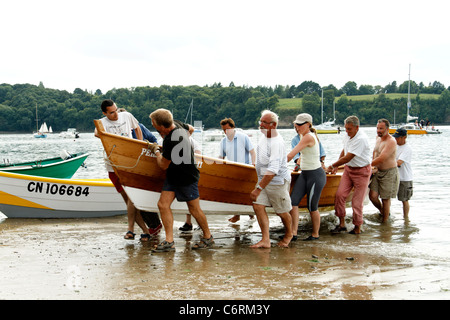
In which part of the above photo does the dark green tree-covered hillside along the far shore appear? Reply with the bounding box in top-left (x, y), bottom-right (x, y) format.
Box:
top-left (0, 81), bottom-right (450, 132)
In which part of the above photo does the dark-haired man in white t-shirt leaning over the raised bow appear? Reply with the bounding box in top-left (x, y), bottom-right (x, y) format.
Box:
top-left (94, 99), bottom-right (150, 241)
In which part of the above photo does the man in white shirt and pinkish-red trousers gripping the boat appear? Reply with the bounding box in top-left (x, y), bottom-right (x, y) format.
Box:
top-left (327, 116), bottom-right (372, 234)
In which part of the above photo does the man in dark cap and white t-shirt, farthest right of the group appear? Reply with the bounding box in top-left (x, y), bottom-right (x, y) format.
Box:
top-left (393, 128), bottom-right (413, 219)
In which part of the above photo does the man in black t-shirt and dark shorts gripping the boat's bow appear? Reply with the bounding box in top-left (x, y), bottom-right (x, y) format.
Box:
top-left (150, 109), bottom-right (214, 252)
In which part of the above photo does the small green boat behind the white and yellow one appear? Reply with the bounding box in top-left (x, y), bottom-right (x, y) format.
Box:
top-left (0, 150), bottom-right (89, 179)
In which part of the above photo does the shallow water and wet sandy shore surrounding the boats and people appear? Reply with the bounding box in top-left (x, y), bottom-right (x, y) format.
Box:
top-left (0, 127), bottom-right (450, 300)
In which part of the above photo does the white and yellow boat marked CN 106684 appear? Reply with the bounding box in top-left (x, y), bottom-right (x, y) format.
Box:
top-left (0, 171), bottom-right (127, 218)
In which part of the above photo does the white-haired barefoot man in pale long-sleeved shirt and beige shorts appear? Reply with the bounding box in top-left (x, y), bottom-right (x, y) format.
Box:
top-left (250, 110), bottom-right (292, 248)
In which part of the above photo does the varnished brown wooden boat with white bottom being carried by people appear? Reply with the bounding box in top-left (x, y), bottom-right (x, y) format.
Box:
top-left (94, 120), bottom-right (341, 214)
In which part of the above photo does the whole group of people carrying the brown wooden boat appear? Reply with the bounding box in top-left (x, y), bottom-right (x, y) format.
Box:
top-left (96, 100), bottom-right (412, 252)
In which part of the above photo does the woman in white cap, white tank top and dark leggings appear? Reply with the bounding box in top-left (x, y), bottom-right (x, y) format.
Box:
top-left (287, 113), bottom-right (327, 240)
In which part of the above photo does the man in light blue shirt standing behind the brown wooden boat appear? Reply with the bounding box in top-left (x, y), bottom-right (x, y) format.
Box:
top-left (219, 118), bottom-right (256, 222)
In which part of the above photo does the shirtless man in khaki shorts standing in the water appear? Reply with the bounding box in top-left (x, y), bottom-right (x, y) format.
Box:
top-left (369, 119), bottom-right (399, 222)
